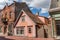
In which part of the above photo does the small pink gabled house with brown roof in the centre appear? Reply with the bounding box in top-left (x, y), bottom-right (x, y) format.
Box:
top-left (14, 9), bottom-right (48, 37)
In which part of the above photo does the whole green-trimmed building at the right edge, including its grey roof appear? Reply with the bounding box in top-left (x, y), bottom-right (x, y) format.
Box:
top-left (49, 0), bottom-right (60, 39)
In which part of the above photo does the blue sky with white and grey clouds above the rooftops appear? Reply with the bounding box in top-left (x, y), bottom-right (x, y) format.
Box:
top-left (0, 0), bottom-right (51, 17)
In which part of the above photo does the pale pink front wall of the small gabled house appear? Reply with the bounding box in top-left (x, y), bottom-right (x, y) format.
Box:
top-left (14, 11), bottom-right (36, 37)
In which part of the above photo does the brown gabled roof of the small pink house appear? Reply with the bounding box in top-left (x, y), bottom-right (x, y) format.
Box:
top-left (14, 9), bottom-right (43, 26)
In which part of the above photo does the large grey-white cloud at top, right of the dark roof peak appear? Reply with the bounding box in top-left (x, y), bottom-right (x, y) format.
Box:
top-left (22, 0), bottom-right (50, 9)
